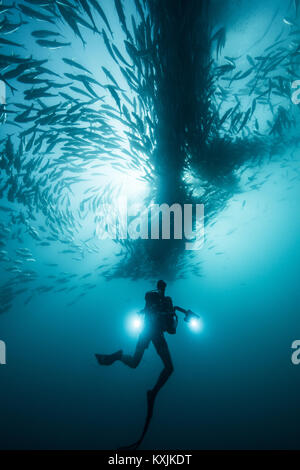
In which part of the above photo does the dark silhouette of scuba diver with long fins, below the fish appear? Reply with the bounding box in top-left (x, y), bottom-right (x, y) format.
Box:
top-left (95, 280), bottom-right (179, 449)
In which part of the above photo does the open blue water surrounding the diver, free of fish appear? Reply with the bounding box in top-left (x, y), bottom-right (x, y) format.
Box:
top-left (0, 0), bottom-right (300, 449)
